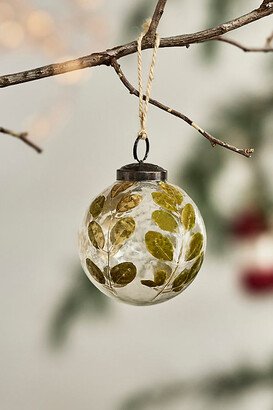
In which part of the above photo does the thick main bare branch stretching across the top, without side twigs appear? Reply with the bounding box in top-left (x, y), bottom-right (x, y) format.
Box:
top-left (0, 1), bottom-right (273, 87)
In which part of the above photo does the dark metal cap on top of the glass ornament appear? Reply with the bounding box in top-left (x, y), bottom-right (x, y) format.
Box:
top-left (117, 162), bottom-right (168, 181)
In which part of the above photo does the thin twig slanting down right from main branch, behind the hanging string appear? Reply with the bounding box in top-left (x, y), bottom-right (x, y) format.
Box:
top-left (111, 58), bottom-right (254, 158)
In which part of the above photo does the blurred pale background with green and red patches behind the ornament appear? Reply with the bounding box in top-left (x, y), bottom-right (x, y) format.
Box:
top-left (0, 0), bottom-right (273, 410)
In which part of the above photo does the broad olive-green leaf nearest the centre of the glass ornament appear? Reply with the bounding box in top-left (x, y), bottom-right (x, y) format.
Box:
top-left (145, 231), bottom-right (173, 261)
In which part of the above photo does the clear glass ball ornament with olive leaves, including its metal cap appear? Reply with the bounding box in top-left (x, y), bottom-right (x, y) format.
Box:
top-left (79, 162), bottom-right (206, 305)
